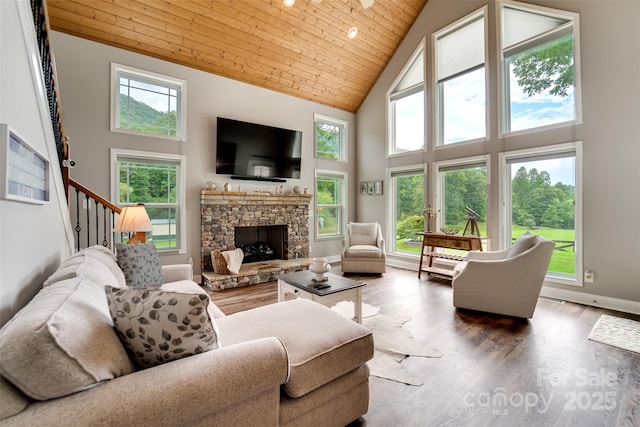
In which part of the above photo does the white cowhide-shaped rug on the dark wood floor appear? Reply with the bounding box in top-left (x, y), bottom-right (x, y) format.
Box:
top-left (332, 301), bottom-right (442, 386)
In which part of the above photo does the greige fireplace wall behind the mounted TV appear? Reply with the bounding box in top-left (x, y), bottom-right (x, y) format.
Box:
top-left (53, 32), bottom-right (356, 274)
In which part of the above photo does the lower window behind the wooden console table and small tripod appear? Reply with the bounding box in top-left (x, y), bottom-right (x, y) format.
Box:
top-left (436, 157), bottom-right (488, 253)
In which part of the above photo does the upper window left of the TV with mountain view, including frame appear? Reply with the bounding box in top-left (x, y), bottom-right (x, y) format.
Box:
top-left (111, 64), bottom-right (186, 140)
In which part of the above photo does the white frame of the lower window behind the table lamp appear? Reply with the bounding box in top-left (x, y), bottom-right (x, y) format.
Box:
top-left (110, 148), bottom-right (187, 254)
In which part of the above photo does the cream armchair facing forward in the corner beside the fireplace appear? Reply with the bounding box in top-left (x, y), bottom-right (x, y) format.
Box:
top-left (342, 222), bottom-right (387, 273)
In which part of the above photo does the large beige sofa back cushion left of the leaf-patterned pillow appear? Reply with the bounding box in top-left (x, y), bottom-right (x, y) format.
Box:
top-left (0, 278), bottom-right (134, 400)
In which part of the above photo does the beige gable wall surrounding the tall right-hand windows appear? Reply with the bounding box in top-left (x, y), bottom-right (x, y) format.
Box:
top-left (357, 0), bottom-right (640, 307)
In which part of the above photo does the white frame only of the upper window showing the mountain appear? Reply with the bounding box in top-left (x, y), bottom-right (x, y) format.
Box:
top-left (109, 62), bottom-right (187, 141)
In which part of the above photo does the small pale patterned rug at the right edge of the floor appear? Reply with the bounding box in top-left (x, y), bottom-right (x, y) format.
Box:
top-left (589, 314), bottom-right (640, 353)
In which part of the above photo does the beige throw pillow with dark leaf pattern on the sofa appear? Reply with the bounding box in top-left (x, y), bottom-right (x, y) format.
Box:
top-left (105, 286), bottom-right (220, 368)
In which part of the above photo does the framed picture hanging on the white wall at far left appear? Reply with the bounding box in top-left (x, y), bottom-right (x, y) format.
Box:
top-left (0, 123), bottom-right (51, 204)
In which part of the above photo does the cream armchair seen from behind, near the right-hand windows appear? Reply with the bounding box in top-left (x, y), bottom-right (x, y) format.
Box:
top-left (451, 232), bottom-right (555, 319)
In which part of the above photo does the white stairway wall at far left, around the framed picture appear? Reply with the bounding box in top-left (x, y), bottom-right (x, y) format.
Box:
top-left (0, 0), bottom-right (73, 326)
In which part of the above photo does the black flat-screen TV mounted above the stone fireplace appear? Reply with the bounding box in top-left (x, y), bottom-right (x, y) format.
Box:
top-left (216, 117), bottom-right (302, 182)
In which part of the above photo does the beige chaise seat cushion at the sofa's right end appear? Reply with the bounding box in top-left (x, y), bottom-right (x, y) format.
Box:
top-left (217, 298), bottom-right (373, 397)
